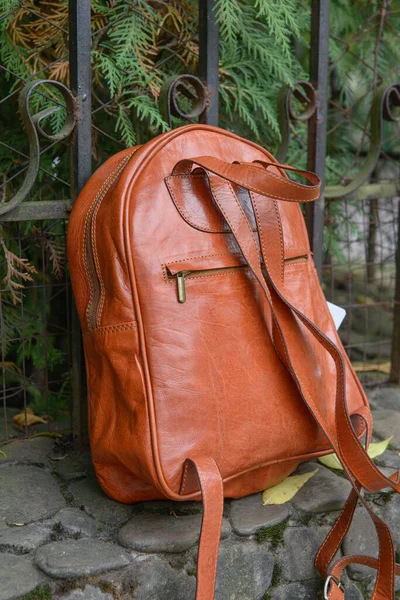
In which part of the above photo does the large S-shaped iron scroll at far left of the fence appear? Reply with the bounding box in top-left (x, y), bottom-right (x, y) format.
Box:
top-left (0, 79), bottom-right (78, 215)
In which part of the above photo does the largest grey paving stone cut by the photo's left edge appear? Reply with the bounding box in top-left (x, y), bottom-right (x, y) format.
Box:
top-left (0, 466), bottom-right (65, 525)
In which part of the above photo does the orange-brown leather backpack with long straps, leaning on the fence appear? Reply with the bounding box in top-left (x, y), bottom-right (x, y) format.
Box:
top-left (68, 125), bottom-right (400, 600)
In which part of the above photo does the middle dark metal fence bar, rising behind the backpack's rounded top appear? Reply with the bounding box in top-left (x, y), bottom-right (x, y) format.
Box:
top-left (199, 0), bottom-right (219, 125)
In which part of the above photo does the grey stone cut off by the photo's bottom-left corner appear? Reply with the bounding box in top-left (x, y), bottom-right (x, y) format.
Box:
top-left (0, 552), bottom-right (41, 600)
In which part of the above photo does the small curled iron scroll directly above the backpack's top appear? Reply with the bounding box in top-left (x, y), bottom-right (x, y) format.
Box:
top-left (159, 75), bottom-right (208, 127)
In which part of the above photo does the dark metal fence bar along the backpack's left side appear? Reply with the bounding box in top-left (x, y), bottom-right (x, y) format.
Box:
top-left (69, 0), bottom-right (92, 444)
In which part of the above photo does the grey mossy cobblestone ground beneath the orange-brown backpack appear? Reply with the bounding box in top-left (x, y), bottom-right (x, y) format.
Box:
top-left (0, 387), bottom-right (400, 600)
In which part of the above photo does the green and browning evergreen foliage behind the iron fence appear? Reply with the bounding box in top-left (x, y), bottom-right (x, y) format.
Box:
top-left (0, 0), bottom-right (400, 418)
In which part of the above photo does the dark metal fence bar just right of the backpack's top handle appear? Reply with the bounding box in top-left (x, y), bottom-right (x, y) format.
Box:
top-left (306, 0), bottom-right (330, 277)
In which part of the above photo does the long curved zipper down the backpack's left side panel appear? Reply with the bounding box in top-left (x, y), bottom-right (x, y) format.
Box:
top-left (84, 147), bottom-right (139, 329)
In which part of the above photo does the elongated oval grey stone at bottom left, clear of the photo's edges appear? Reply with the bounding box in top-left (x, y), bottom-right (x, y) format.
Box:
top-left (35, 538), bottom-right (131, 579)
